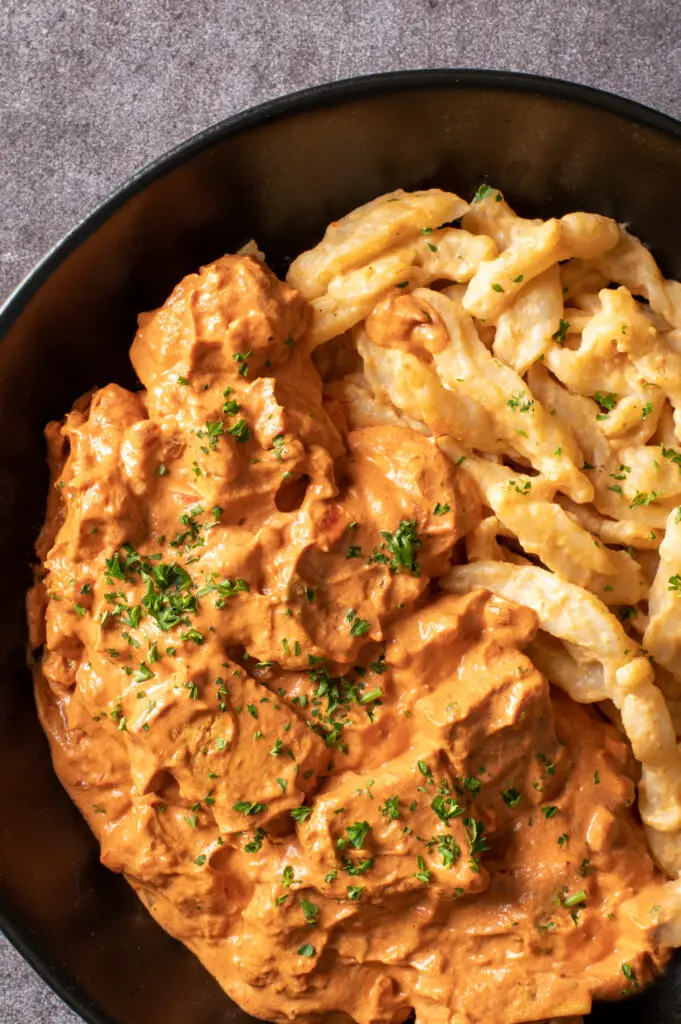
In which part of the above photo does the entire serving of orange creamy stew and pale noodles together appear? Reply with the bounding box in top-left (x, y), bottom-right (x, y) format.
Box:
top-left (29, 185), bottom-right (681, 1024)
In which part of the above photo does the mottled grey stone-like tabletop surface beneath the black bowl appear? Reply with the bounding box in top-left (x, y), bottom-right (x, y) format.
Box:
top-left (0, 0), bottom-right (681, 1024)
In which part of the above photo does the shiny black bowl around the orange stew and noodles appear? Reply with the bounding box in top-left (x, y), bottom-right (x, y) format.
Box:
top-left (0, 71), bottom-right (681, 1024)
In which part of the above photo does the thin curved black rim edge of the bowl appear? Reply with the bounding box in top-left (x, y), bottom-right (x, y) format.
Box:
top-left (0, 68), bottom-right (681, 1024)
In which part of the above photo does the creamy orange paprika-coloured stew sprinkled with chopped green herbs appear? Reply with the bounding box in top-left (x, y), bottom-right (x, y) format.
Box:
top-left (29, 249), bottom-right (664, 1024)
